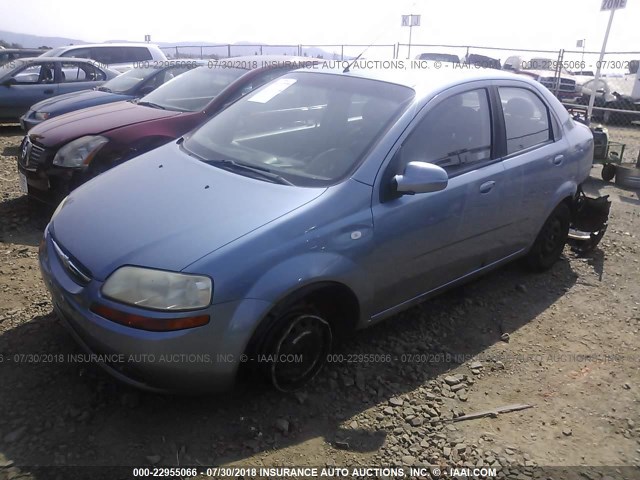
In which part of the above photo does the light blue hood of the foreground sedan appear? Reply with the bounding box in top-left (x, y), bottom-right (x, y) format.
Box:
top-left (49, 142), bottom-right (326, 281)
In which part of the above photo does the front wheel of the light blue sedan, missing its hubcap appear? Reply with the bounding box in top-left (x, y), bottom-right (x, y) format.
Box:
top-left (258, 306), bottom-right (333, 392)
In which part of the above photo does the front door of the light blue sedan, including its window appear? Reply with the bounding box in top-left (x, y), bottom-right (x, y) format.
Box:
top-left (372, 82), bottom-right (514, 313)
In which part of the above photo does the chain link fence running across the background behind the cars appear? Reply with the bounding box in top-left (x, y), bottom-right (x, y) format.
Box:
top-left (162, 43), bottom-right (640, 130)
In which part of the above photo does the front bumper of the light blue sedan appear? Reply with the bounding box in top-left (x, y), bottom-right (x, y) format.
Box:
top-left (40, 228), bottom-right (270, 392)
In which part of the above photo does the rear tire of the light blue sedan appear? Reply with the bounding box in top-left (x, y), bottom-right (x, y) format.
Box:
top-left (526, 203), bottom-right (571, 272)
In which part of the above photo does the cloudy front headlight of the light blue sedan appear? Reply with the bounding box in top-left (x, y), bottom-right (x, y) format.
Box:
top-left (102, 266), bottom-right (213, 311)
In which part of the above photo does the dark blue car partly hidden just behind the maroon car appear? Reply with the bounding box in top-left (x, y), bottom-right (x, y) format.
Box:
top-left (20, 60), bottom-right (204, 131)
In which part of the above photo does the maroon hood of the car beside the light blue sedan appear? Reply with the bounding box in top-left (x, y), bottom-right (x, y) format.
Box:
top-left (29, 102), bottom-right (182, 147)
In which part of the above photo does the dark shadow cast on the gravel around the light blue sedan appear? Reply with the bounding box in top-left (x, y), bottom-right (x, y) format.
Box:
top-left (0, 253), bottom-right (578, 478)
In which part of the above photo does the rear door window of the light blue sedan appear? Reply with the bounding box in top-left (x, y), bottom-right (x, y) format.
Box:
top-left (498, 87), bottom-right (553, 155)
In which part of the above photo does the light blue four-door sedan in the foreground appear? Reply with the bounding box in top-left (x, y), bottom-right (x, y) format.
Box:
top-left (40, 65), bottom-right (593, 391)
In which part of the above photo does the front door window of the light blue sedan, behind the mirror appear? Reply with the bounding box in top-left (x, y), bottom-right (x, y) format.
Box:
top-left (401, 88), bottom-right (491, 175)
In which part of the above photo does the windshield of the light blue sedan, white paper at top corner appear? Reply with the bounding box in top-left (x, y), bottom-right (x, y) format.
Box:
top-left (183, 72), bottom-right (415, 187)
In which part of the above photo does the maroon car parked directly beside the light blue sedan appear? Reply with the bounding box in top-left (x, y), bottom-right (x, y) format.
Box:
top-left (18, 56), bottom-right (315, 204)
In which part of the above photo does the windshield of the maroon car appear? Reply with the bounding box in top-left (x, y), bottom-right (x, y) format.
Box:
top-left (139, 67), bottom-right (247, 112)
